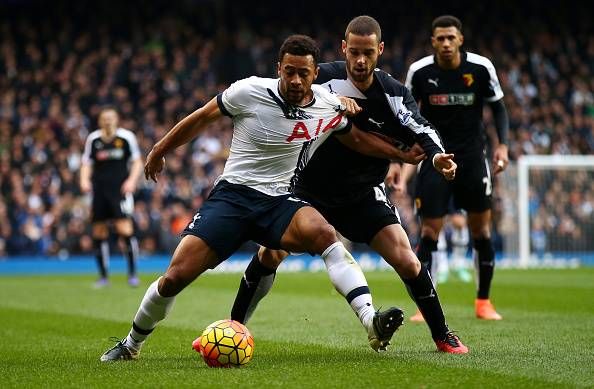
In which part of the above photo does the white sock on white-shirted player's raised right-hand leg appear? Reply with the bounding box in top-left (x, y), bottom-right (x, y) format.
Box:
top-left (322, 242), bottom-right (375, 329)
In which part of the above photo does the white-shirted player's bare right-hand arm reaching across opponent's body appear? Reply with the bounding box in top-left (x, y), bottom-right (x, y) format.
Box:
top-left (336, 126), bottom-right (426, 164)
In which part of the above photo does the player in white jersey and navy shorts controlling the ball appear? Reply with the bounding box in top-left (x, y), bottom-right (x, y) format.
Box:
top-left (101, 35), bottom-right (420, 361)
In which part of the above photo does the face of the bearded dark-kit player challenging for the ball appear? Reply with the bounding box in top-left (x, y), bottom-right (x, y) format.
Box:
top-left (342, 33), bottom-right (384, 82)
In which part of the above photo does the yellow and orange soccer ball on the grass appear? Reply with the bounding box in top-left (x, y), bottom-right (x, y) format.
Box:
top-left (192, 319), bottom-right (254, 367)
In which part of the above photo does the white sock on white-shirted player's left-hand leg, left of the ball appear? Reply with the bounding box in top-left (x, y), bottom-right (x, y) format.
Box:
top-left (124, 278), bottom-right (175, 351)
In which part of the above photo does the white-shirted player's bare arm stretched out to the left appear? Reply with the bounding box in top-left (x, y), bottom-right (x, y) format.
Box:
top-left (144, 97), bottom-right (222, 182)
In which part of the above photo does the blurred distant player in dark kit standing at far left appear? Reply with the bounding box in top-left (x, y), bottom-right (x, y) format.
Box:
top-left (80, 108), bottom-right (142, 287)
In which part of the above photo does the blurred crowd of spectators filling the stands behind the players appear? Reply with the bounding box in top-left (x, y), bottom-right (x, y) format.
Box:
top-left (0, 1), bottom-right (594, 256)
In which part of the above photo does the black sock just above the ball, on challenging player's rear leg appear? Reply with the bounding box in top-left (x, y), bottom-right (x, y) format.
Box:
top-left (231, 253), bottom-right (276, 324)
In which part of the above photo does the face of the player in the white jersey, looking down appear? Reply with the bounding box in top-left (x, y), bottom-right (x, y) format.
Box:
top-left (277, 53), bottom-right (318, 105)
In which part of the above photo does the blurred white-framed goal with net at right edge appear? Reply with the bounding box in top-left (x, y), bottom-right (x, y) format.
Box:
top-left (508, 155), bottom-right (594, 267)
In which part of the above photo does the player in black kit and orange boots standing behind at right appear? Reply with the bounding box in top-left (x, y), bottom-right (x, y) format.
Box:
top-left (406, 15), bottom-right (509, 320)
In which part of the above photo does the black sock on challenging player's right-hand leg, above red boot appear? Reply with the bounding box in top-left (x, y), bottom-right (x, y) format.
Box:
top-left (403, 265), bottom-right (448, 339)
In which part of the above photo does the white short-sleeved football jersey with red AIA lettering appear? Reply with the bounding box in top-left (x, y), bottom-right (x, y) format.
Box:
top-left (217, 77), bottom-right (350, 196)
